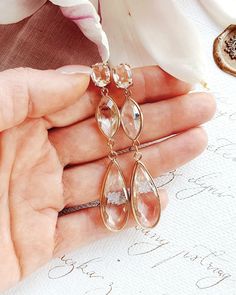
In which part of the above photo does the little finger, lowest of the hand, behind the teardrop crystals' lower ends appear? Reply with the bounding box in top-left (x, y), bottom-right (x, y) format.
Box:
top-left (54, 190), bottom-right (168, 257)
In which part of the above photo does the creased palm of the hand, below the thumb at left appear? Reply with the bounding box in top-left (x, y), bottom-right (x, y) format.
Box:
top-left (0, 119), bottom-right (64, 290)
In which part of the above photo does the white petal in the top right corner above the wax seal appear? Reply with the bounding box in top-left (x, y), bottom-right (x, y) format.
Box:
top-left (199, 0), bottom-right (236, 28)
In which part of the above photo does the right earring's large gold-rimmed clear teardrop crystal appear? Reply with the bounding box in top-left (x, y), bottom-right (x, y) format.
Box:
top-left (131, 162), bottom-right (161, 228)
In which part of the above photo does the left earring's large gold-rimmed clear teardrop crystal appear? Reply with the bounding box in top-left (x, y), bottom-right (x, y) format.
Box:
top-left (100, 160), bottom-right (129, 231)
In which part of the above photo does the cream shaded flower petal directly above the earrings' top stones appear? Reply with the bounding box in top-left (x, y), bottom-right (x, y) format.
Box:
top-left (101, 0), bottom-right (156, 67)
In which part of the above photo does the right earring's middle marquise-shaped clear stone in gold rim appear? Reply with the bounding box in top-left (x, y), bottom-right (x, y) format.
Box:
top-left (121, 98), bottom-right (142, 140)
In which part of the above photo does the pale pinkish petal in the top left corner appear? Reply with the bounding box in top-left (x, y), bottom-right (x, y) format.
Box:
top-left (0, 0), bottom-right (47, 24)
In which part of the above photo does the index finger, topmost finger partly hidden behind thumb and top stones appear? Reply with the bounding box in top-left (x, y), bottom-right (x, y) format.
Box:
top-left (44, 66), bottom-right (191, 126)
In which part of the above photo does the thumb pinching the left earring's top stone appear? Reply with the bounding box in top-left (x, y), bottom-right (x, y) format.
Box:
top-left (0, 66), bottom-right (90, 131)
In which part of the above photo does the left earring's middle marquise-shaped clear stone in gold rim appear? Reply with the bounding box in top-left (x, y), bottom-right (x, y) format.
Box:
top-left (96, 96), bottom-right (120, 138)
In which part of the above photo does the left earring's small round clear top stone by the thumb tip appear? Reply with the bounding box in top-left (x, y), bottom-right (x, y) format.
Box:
top-left (91, 63), bottom-right (111, 87)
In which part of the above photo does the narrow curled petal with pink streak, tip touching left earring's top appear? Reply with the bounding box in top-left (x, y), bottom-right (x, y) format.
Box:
top-left (61, 1), bottom-right (109, 62)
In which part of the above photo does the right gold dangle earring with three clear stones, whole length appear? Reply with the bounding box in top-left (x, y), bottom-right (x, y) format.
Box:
top-left (113, 64), bottom-right (161, 228)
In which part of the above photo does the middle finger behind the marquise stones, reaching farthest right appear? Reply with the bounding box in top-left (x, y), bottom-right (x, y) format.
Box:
top-left (50, 93), bottom-right (215, 165)
